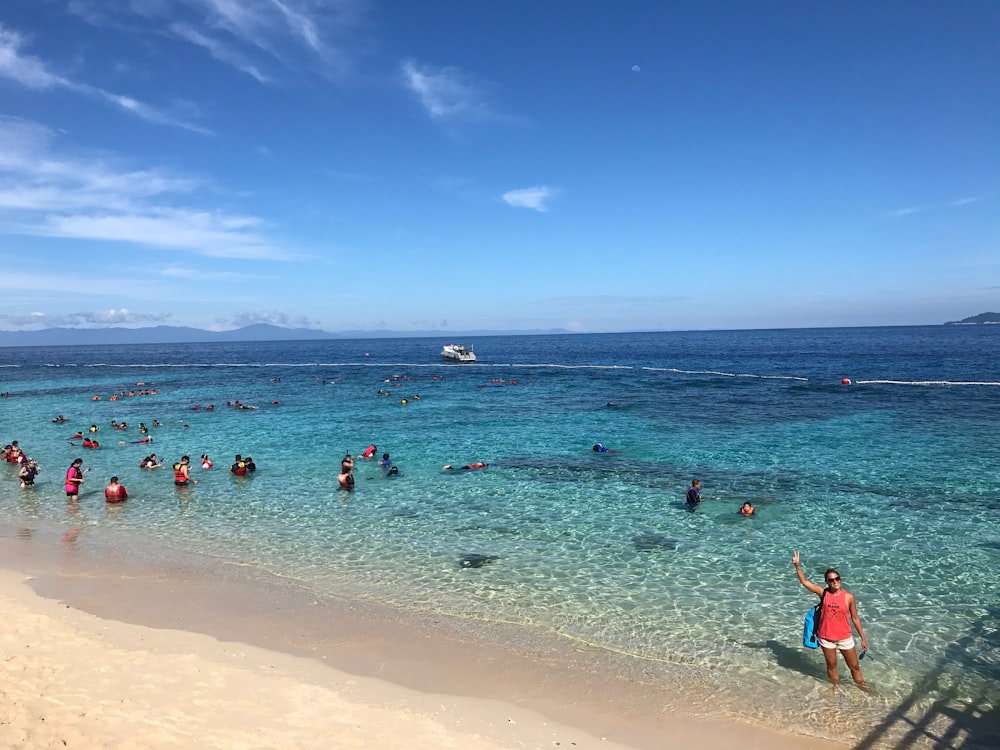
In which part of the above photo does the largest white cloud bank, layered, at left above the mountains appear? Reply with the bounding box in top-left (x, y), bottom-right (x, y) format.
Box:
top-left (0, 118), bottom-right (292, 260)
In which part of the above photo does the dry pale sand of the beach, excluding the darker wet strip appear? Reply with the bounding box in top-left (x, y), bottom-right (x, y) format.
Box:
top-left (0, 571), bottom-right (624, 749)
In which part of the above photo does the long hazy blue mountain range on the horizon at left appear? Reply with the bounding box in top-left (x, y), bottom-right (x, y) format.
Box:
top-left (0, 323), bottom-right (569, 346)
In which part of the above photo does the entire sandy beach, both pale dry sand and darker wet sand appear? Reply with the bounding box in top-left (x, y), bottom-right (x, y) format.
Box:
top-left (0, 528), bottom-right (841, 750)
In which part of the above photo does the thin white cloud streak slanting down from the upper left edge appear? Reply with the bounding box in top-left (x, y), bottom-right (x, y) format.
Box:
top-left (0, 25), bottom-right (212, 135)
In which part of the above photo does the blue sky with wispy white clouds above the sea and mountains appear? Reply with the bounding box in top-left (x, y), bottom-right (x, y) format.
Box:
top-left (0, 0), bottom-right (1000, 331)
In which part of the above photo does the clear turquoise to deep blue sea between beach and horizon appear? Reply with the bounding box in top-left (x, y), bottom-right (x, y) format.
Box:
top-left (0, 326), bottom-right (1000, 748)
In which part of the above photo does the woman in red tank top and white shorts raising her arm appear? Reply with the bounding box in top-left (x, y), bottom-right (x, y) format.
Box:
top-left (792, 550), bottom-right (869, 692)
